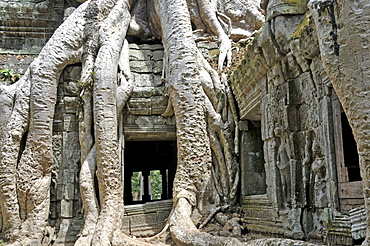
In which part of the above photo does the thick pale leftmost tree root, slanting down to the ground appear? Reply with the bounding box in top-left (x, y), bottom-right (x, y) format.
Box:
top-left (0, 2), bottom-right (85, 244)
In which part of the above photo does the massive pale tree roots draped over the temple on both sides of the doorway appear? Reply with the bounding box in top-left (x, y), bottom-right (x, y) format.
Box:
top-left (0, 0), bottom-right (262, 245)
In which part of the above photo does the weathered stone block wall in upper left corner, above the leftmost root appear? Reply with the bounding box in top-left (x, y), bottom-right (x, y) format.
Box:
top-left (0, 0), bottom-right (74, 54)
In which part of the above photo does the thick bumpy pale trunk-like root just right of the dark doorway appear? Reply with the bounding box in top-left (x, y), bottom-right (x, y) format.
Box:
top-left (154, 0), bottom-right (241, 245)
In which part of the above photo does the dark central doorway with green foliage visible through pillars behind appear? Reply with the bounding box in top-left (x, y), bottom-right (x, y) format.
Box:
top-left (124, 141), bottom-right (177, 205)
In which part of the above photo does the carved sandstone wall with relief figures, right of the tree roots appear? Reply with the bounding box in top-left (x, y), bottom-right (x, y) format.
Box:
top-left (231, 0), bottom-right (366, 245)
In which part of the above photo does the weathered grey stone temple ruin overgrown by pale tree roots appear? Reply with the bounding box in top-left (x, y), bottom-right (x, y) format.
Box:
top-left (0, 0), bottom-right (366, 245)
